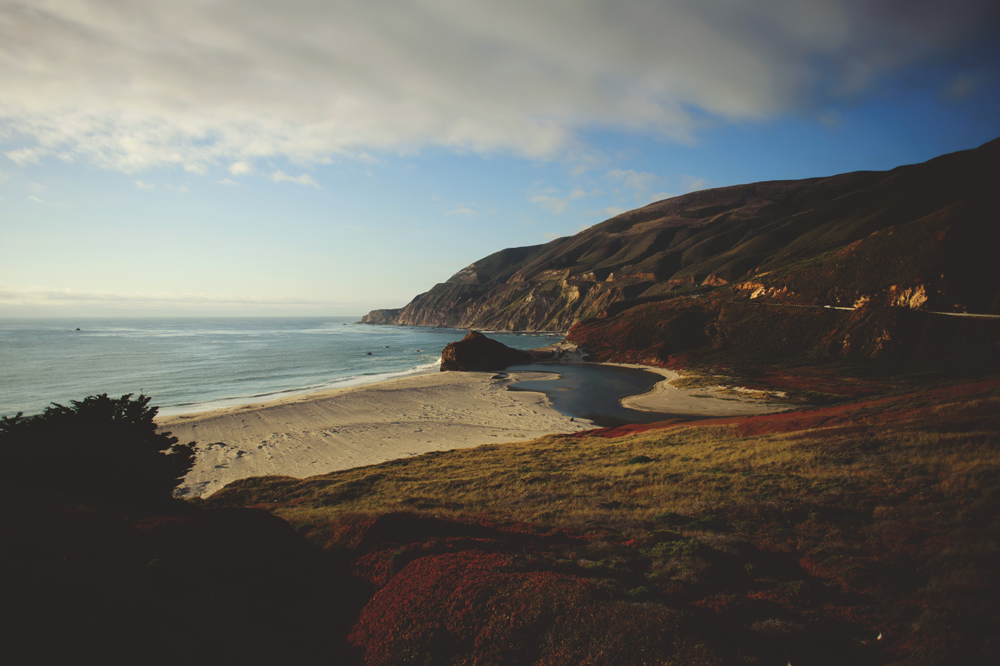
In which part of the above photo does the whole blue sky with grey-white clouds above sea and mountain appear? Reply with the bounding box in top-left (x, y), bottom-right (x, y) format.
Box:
top-left (0, 0), bottom-right (1000, 317)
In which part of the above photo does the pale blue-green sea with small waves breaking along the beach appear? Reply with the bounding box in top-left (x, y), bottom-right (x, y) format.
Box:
top-left (0, 317), bottom-right (561, 416)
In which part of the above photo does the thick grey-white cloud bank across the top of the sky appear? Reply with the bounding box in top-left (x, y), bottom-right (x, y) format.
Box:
top-left (0, 0), bottom-right (1000, 171)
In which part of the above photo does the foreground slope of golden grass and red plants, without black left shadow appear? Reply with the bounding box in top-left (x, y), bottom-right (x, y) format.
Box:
top-left (208, 379), bottom-right (1000, 664)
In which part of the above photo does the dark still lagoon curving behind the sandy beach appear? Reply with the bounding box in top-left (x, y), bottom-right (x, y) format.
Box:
top-left (507, 363), bottom-right (691, 428)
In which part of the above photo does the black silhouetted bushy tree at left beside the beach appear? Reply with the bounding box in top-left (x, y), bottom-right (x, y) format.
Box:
top-left (0, 393), bottom-right (194, 507)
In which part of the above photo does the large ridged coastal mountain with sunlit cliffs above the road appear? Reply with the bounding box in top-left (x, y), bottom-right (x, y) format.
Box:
top-left (363, 140), bottom-right (1000, 340)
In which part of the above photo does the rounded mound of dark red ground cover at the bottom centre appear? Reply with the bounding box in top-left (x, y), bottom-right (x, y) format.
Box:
top-left (350, 551), bottom-right (675, 666)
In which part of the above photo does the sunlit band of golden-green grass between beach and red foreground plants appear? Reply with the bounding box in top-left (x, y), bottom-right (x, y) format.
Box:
top-left (211, 390), bottom-right (1000, 539)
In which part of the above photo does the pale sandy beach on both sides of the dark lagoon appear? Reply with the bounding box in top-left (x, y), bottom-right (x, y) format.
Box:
top-left (157, 368), bottom-right (783, 497)
